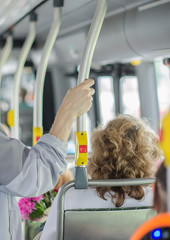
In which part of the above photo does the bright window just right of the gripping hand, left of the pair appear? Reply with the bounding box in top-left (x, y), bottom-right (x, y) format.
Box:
top-left (98, 76), bottom-right (116, 125)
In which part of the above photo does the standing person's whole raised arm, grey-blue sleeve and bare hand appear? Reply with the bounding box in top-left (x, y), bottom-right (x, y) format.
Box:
top-left (0, 79), bottom-right (94, 196)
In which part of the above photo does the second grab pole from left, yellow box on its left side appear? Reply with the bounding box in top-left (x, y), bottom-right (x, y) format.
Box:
top-left (8, 12), bottom-right (37, 139)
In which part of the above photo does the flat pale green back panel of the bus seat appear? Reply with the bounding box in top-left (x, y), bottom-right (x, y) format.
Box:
top-left (64, 207), bottom-right (156, 240)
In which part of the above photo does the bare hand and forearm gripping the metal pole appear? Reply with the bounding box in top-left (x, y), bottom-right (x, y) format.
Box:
top-left (50, 79), bottom-right (95, 141)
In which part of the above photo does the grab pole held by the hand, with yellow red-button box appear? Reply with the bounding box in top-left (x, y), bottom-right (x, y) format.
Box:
top-left (75, 0), bottom-right (108, 189)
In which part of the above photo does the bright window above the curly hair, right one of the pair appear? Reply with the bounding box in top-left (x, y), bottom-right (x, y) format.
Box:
top-left (120, 76), bottom-right (140, 117)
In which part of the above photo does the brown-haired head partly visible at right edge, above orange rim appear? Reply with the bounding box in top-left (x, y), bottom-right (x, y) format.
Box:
top-left (154, 162), bottom-right (167, 213)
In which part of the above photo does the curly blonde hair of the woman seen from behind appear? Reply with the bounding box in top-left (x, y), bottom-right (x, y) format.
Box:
top-left (88, 115), bottom-right (161, 207)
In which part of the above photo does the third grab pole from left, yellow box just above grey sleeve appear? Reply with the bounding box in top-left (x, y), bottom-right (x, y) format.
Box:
top-left (33, 0), bottom-right (64, 145)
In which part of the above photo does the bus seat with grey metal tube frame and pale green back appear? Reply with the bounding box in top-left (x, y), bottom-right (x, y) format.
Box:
top-left (57, 179), bottom-right (156, 240)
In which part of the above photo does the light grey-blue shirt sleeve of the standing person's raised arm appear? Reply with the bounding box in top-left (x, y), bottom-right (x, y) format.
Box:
top-left (0, 124), bottom-right (67, 197)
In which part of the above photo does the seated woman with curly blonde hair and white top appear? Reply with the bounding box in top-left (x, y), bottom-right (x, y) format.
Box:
top-left (40, 115), bottom-right (161, 240)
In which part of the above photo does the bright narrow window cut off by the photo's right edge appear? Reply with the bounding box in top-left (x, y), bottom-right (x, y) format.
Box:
top-left (154, 60), bottom-right (170, 120)
